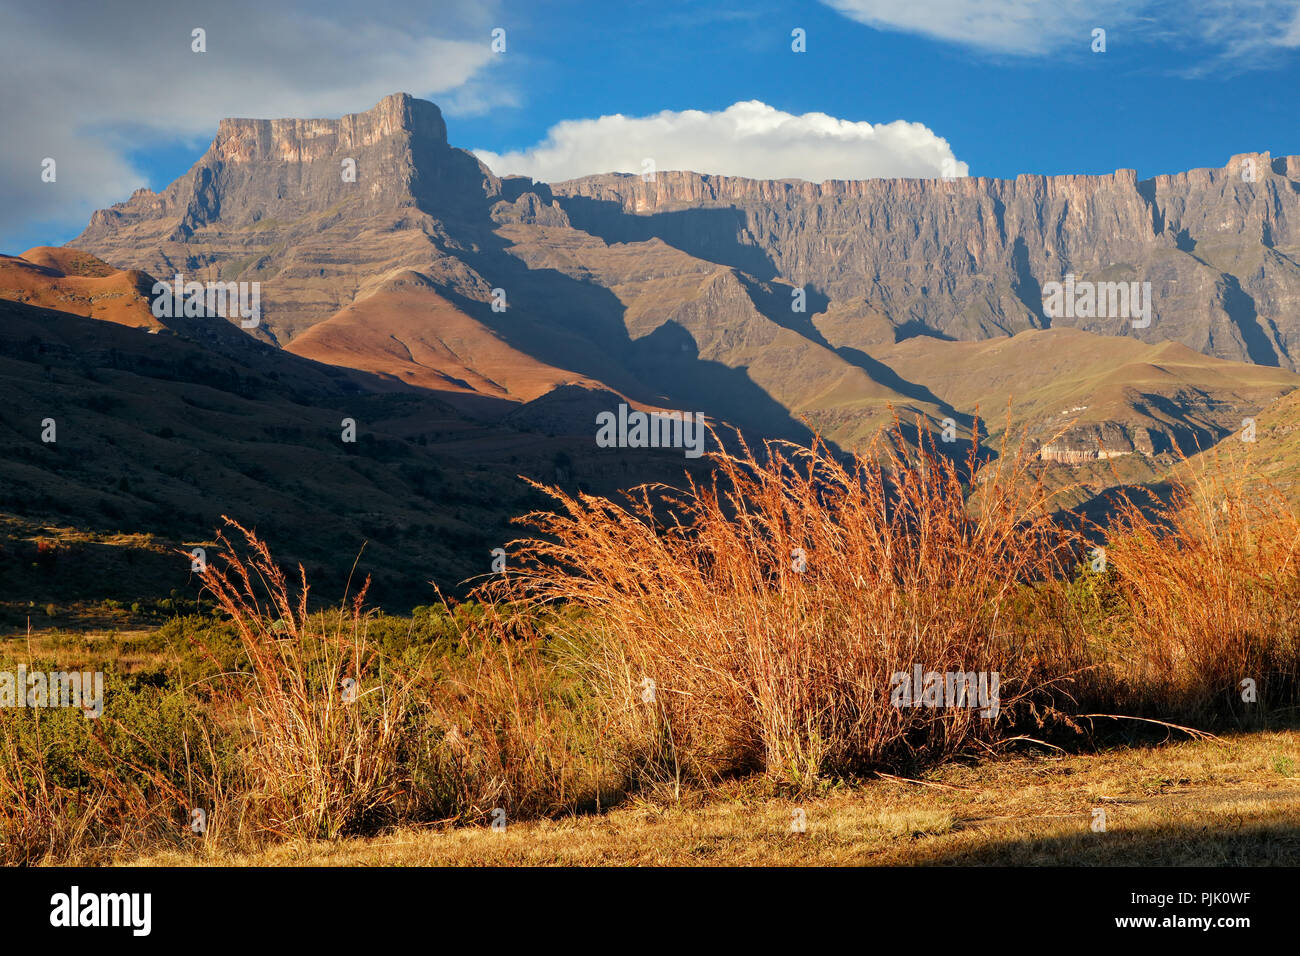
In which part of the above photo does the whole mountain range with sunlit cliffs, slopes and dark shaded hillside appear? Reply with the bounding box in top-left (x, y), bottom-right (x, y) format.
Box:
top-left (0, 94), bottom-right (1300, 613)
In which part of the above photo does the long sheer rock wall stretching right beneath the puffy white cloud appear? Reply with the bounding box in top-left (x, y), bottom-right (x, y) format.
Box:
top-left (551, 153), bottom-right (1300, 368)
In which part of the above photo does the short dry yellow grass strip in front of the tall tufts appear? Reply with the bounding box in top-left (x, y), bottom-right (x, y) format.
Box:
top-left (117, 731), bottom-right (1300, 866)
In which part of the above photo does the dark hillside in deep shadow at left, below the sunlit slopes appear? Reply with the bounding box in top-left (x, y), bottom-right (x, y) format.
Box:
top-left (0, 300), bottom-right (712, 616)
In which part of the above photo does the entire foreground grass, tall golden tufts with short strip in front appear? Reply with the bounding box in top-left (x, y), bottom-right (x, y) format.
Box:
top-left (0, 426), bottom-right (1300, 862)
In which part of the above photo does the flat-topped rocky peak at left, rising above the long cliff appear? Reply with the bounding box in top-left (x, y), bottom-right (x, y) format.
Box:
top-left (70, 92), bottom-right (501, 341)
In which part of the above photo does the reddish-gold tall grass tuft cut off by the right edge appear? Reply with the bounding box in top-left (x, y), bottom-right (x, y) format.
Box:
top-left (1100, 455), bottom-right (1300, 723)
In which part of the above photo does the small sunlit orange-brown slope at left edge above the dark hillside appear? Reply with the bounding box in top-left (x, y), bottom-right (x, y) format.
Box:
top-left (0, 246), bottom-right (163, 329)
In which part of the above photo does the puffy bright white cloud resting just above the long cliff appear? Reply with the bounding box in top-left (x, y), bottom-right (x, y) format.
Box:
top-left (475, 100), bottom-right (969, 182)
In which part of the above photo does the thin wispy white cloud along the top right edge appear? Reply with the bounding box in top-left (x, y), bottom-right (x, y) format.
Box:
top-left (823, 0), bottom-right (1300, 59)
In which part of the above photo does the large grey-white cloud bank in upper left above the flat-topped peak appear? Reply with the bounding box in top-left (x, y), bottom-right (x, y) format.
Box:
top-left (0, 0), bottom-right (508, 252)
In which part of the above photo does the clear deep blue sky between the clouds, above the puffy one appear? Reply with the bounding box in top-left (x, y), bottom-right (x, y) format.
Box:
top-left (449, 1), bottom-right (1300, 177)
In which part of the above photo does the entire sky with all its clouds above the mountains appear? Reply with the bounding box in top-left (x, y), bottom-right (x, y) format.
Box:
top-left (0, 0), bottom-right (1300, 254)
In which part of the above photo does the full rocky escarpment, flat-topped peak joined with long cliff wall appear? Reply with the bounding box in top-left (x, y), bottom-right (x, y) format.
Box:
top-left (73, 94), bottom-right (1300, 368)
